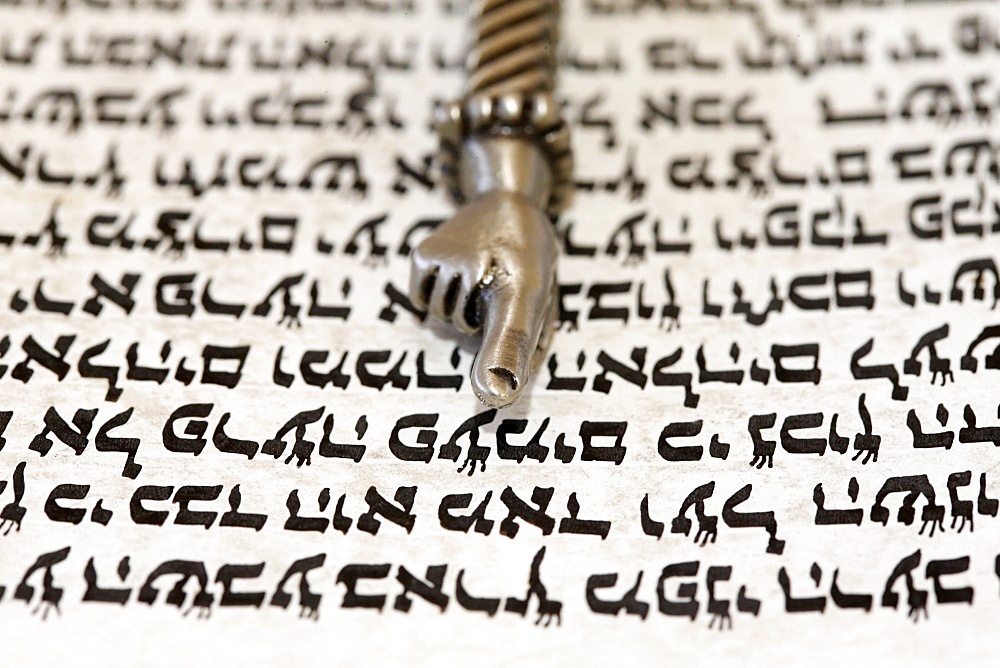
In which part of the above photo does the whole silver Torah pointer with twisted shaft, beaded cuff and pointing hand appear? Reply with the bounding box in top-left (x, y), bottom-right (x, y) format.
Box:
top-left (410, 0), bottom-right (573, 408)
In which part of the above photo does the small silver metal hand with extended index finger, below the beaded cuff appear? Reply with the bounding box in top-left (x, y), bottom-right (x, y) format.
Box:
top-left (410, 157), bottom-right (559, 408)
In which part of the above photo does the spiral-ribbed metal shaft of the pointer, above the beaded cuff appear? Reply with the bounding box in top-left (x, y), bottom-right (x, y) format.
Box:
top-left (468, 0), bottom-right (559, 97)
